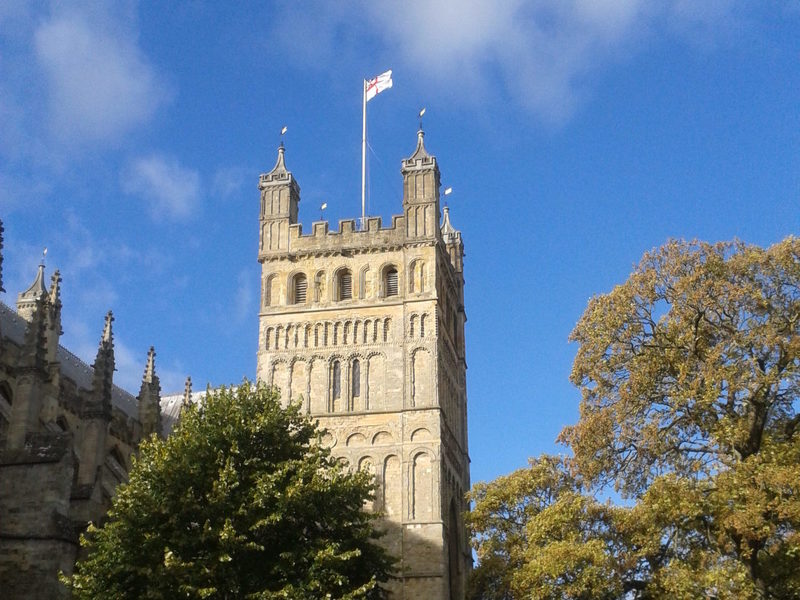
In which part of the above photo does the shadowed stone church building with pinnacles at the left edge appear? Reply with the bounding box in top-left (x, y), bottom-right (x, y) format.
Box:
top-left (0, 225), bottom-right (161, 600)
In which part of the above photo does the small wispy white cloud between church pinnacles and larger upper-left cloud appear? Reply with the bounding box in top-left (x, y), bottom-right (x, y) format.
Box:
top-left (122, 154), bottom-right (201, 220)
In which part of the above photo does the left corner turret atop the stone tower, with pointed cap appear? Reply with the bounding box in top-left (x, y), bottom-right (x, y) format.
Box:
top-left (258, 143), bottom-right (300, 258)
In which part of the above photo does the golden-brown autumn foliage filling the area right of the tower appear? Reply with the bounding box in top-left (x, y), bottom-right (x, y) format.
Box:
top-left (470, 238), bottom-right (800, 599)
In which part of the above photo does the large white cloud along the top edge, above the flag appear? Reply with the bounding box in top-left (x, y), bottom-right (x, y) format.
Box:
top-left (275, 0), bottom-right (752, 123)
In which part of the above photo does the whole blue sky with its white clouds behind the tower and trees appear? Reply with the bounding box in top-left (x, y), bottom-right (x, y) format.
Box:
top-left (0, 0), bottom-right (800, 488)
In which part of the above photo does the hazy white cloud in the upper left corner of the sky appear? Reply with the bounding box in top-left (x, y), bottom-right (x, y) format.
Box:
top-left (34, 5), bottom-right (169, 142)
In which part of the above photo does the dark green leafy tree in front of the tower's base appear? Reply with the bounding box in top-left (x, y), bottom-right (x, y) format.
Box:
top-left (65, 383), bottom-right (391, 600)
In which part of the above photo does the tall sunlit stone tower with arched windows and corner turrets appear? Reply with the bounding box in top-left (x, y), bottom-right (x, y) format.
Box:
top-left (257, 131), bottom-right (472, 600)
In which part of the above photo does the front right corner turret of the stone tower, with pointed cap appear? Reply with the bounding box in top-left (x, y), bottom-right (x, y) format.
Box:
top-left (400, 129), bottom-right (439, 239)
